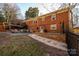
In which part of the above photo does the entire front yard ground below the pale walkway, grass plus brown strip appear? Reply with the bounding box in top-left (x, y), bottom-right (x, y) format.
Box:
top-left (0, 33), bottom-right (68, 56)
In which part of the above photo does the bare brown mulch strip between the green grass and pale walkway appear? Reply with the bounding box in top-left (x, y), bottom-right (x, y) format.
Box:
top-left (29, 36), bottom-right (68, 56)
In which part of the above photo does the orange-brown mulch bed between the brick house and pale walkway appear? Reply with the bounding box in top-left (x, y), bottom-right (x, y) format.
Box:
top-left (35, 33), bottom-right (66, 43)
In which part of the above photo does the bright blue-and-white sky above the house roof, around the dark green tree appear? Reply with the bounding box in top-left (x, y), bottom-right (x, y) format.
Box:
top-left (17, 3), bottom-right (59, 19)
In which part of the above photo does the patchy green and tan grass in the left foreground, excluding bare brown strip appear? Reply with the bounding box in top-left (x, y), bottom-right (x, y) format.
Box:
top-left (0, 36), bottom-right (46, 56)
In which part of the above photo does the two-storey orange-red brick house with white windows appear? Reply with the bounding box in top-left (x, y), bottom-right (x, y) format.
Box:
top-left (25, 8), bottom-right (69, 32)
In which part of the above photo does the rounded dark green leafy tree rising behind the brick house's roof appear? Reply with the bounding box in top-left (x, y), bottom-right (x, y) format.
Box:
top-left (25, 7), bottom-right (39, 19)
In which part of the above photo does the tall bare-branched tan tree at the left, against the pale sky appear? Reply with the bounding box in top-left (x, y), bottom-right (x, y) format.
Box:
top-left (2, 3), bottom-right (19, 29)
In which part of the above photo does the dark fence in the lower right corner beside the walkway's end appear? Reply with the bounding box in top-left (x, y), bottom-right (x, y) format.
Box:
top-left (66, 31), bottom-right (79, 56)
